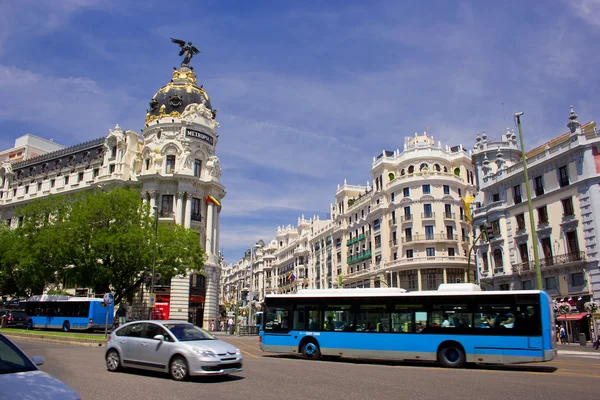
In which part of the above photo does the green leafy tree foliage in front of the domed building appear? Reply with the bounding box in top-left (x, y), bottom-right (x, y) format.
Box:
top-left (0, 188), bottom-right (204, 304)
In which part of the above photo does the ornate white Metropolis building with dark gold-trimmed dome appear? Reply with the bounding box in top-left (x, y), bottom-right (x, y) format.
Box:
top-left (0, 44), bottom-right (225, 327)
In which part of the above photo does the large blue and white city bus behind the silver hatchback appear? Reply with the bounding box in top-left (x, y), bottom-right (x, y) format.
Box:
top-left (259, 283), bottom-right (556, 368)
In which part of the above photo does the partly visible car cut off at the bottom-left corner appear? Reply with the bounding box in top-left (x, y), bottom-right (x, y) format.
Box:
top-left (0, 334), bottom-right (81, 400)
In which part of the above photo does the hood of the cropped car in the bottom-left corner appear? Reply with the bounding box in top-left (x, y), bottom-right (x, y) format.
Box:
top-left (0, 371), bottom-right (81, 400)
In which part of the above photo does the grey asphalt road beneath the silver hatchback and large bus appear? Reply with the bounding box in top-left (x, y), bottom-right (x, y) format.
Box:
top-left (16, 336), bottom-right (600, 400)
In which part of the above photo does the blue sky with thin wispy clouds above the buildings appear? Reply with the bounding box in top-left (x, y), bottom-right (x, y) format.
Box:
top-left (0, 0), bottom-right (600, 263)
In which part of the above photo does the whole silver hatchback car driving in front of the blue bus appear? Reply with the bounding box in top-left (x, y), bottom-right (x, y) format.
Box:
top-left (105, 321), bottom-right (242, 381)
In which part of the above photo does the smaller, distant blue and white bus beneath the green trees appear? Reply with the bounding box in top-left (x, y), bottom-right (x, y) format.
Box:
top-left (22, 295), bottom-right (114, 332)
